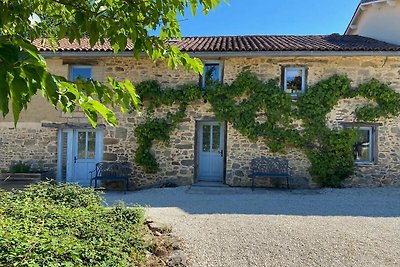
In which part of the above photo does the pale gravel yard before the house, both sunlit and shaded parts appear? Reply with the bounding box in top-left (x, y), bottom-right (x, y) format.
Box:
top-left (106, 187), bottom-right (400, 266)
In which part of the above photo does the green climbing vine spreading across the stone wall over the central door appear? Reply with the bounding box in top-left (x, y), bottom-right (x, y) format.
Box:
top-left (135, 71), bottom-right (400, 187)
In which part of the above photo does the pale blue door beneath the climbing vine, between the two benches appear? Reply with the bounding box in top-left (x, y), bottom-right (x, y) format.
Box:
top-left (197, 122), bottom-right (225, 182)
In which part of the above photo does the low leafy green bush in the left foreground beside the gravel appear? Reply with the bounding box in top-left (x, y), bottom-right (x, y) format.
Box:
top-left (0, 183), bottom-right (145, 266)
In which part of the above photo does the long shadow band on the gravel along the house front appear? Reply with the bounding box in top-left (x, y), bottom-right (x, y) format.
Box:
top-left (105, 187), bottom-right (400, 217)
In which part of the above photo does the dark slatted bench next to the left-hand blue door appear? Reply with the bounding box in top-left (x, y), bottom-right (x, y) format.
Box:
top-left (90, 161), bottom-right (132, 191)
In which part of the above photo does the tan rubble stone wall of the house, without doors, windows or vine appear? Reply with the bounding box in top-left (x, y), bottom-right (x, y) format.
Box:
top-left (0, 56), bottom-right (400, 188)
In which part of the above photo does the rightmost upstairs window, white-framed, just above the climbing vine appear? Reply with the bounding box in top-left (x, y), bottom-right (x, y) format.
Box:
top-left (282, 67), bottom-right (306, 98)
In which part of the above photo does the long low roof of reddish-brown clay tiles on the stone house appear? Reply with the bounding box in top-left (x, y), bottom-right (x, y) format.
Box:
top-left (33, 34), bottom-right (400, 52)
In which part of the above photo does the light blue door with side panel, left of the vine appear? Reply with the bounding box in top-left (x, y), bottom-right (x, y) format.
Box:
top-left (58, 129), bottom-right (103, 186)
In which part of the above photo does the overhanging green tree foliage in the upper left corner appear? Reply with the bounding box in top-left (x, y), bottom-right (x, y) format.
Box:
top-left (0, 0), bottom-right (220, 125)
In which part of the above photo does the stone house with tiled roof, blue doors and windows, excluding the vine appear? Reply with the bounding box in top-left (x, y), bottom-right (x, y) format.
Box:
top-left (0, 1), bottom-right (400, 188)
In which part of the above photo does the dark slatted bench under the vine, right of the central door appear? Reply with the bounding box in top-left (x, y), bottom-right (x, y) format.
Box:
top-left (250, 157), bottom-right (290, 190)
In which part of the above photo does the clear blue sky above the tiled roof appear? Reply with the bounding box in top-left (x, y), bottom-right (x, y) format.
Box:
top-left (180, 0), bottom-right (360, 36)
